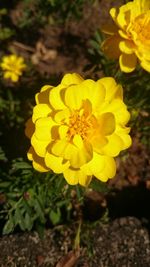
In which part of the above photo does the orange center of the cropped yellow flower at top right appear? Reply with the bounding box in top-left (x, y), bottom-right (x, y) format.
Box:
top-left (128, 11), bottom-right (150, 45)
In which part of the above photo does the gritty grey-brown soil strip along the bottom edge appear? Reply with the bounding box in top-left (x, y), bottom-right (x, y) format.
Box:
top-left (0, 217), bottom-right (150, 267)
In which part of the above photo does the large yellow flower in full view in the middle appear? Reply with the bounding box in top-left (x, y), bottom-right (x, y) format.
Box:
top-left (26, 74), bottom-right (131, 186)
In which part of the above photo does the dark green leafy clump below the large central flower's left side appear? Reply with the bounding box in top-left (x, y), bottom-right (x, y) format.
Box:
top-left (0, 157), bottom-right (76, 234)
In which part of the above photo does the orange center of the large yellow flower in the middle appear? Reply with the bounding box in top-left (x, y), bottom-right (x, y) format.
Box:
top-left (67, 110), bottom-right (92, 140)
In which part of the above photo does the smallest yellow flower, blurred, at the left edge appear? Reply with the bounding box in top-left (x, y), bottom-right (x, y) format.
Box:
top-left (0, 54), bottom-right (26, 82)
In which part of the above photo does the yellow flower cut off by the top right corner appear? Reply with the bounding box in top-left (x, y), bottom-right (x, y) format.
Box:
top-left (102, 0), bottom-right (150, 72)
